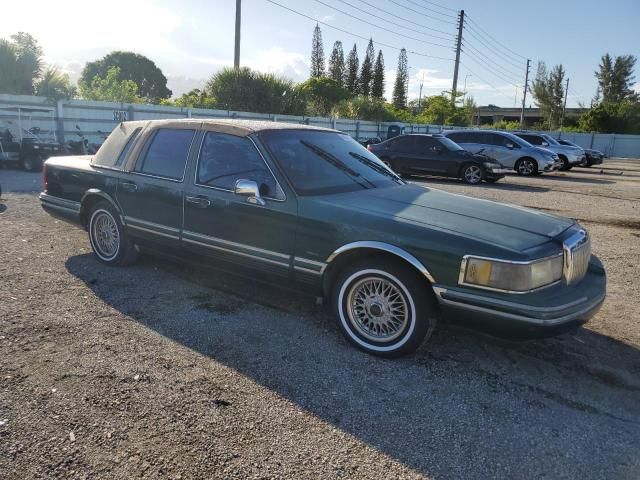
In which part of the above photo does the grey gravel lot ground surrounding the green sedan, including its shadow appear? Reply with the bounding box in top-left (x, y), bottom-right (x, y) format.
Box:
top-left (0, 160), bottom-right (640, 479)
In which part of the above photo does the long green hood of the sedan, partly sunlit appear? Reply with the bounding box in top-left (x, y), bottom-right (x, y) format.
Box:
top-left (322, 185), bottom-right (575, 252)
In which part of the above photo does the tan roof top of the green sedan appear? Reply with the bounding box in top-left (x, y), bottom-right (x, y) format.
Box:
top-left (123, 118), bottom-right (342, 137)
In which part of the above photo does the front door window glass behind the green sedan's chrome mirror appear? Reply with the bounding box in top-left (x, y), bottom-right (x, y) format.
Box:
top-left (196, 132), bottom-right (284, 200)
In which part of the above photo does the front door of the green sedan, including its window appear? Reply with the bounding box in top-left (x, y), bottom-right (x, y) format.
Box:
top-left (182, 132), bottom-right (297, 277)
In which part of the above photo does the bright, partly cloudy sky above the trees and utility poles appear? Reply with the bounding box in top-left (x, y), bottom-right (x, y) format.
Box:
top-left (0, 0), bottom-right (640, 107)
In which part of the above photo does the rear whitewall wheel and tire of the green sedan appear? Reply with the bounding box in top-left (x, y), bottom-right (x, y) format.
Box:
top-left (88, 201), bottom-right (138, 265)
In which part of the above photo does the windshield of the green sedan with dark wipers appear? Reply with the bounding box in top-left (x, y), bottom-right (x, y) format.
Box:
top-left (260, 130), bottom-right (405, 195)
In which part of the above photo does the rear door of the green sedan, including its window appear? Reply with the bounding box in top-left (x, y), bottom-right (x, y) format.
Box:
top-left (116, 127), bottom-right (196, 248)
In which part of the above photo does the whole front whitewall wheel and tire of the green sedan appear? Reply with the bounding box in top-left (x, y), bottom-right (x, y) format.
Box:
top-left (332, 259), bottom-right (436, 357)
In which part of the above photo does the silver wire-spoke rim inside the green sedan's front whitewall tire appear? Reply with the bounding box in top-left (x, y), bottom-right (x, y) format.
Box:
top-left (346, 277), bottom-right (410, 342)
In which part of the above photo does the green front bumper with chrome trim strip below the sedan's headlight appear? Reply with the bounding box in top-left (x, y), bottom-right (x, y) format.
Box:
top-left (434, 257), bottom-right (606, 338)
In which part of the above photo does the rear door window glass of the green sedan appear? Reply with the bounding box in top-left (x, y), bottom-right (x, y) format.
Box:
top-left (136, 128), bottom-right (195, 180)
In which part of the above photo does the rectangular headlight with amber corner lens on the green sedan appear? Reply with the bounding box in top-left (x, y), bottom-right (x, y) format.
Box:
top-left (459, 254), bottom-right (563, 293)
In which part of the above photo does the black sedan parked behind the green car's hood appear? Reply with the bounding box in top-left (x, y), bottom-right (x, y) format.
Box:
top-left (367, 134), bottom-right (507, 185)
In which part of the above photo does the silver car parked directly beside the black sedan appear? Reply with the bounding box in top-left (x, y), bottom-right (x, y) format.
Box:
top-left (442, 130), bottom-right (562, 175)
